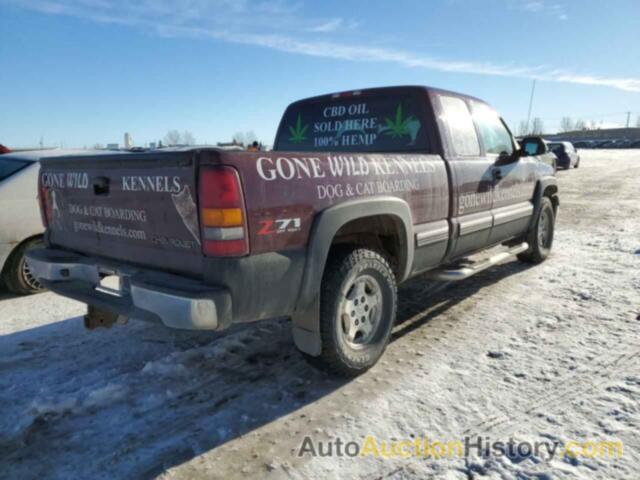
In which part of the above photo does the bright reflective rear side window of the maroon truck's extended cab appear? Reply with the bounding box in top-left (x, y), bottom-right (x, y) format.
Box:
top-left (440, 96), bottom-right (480, 156)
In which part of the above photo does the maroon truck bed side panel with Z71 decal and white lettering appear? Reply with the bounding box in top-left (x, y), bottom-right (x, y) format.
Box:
top-left (208, 152), bottom-right (449, 254)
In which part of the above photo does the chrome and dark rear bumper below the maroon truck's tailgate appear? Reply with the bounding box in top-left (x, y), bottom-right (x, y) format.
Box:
top-left (27, 248), bottom-right (232, 330)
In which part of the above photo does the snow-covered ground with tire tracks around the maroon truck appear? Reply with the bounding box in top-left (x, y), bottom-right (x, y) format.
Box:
top-left (0, 150), bottom-right (640, 479)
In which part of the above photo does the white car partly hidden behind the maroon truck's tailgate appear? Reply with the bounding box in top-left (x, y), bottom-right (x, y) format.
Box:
top-left (0, 150), bottom-right (97, 294)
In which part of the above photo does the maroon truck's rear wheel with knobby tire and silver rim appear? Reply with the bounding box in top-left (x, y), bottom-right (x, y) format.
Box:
top-left (313, 247), bottom-right (397, 377)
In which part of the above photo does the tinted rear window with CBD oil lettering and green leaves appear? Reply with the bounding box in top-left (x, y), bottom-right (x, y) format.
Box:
top-left (275, 95), bottom-right (428, 152)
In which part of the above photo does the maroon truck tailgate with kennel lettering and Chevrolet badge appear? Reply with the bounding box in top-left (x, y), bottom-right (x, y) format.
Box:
top-left (40, 151), bottom-right (202, 275)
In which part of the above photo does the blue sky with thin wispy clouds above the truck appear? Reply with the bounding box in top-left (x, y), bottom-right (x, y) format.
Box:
top-left (0, 0), bottom-right (640, 147)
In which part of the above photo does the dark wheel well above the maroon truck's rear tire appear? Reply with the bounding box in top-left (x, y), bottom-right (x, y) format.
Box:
top-left (331, 215), bottom-right (406, 276)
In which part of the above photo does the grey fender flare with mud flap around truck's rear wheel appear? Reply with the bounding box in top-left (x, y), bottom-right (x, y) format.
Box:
top-left (291, 197), bottom-right (414, 356)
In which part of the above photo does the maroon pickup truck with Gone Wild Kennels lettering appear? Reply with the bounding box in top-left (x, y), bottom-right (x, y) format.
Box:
top-left (29, 86), bottom-right (558, 375)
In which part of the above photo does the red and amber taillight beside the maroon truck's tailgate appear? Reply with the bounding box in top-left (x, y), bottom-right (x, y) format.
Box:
top-left (198, 167), bottom-right (249, 257)
